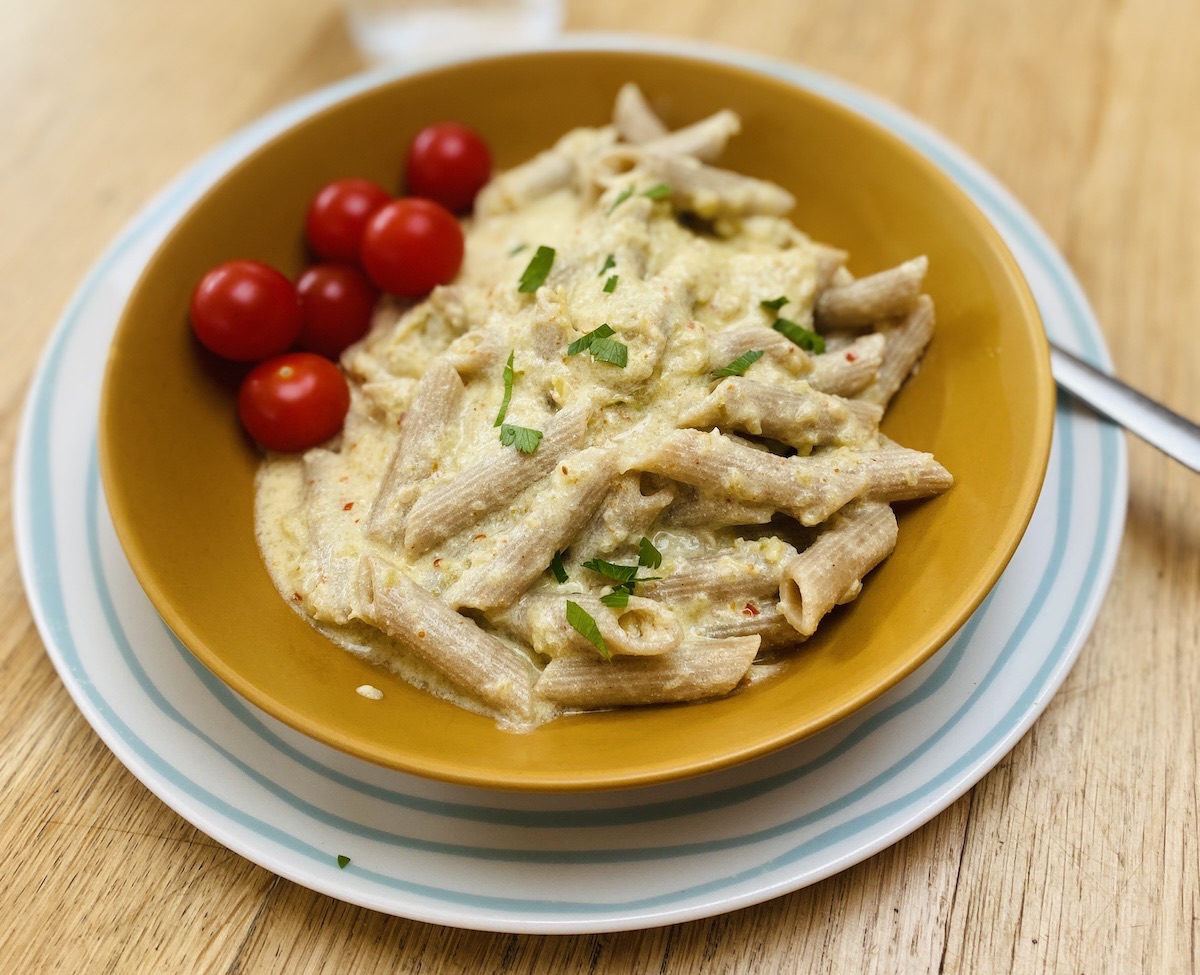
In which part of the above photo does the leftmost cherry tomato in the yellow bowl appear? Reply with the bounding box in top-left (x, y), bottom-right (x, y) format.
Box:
top-left (190, 261), bottom-right (300, 363)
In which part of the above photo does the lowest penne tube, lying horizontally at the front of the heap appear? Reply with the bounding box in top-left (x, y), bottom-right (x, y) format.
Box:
top-left (536, 636), bottom-right (760, 711)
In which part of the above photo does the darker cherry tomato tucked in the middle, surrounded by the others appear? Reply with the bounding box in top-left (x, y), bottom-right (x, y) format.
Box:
top-left (296, 264), bottom-right (379, 359)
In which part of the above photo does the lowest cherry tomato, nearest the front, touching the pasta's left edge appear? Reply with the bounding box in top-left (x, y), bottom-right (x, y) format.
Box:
top-left (238, 352), bottom-right (350, 450)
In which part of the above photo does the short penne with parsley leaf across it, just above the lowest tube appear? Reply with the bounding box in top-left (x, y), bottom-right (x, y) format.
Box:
top-left (497, 593), bottom-right (683, 658)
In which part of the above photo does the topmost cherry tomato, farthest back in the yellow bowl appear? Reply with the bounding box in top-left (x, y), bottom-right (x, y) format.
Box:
top-left (406, 122), bottom-right (492, 214)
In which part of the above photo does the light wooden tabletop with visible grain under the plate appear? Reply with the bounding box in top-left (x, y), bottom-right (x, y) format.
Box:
top-left (0, 0), bottom-right (1200, 975)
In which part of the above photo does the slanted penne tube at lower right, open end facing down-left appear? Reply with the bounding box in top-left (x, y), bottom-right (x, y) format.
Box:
top-left (779, 503), bottom-right (896, 636)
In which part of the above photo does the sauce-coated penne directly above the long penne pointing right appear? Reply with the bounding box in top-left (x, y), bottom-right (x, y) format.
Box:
top-left (679, 376), bottom-right (883, 454)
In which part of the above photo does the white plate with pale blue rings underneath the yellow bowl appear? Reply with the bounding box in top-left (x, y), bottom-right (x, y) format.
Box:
top-left (14, 36), bottom-right (1127, 933)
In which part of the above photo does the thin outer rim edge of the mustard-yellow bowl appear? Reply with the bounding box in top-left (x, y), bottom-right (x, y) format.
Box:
top-left (97, 43), bottom-right (1055, 792)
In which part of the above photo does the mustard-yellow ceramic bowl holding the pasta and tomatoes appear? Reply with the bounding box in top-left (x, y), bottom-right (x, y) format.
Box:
top-left (100, 52), bottom-right (1054, 790)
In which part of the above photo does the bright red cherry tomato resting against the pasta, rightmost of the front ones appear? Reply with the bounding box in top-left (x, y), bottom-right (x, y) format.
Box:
top-left (362, 197), bottom-right (463, 298)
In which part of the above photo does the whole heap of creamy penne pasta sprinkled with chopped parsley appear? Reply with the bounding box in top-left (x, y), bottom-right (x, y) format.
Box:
top-left (256, 85), bottom-right (952, 730)
